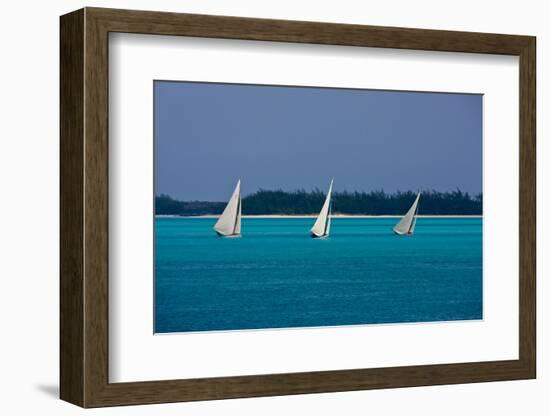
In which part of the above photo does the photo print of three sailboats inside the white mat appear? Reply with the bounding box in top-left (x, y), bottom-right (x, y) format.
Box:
top-left (152, 80), bottom-right (483, 334)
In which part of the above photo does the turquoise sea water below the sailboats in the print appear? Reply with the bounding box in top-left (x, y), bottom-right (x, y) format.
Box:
top-left (155, 218), bottom-right (482, 333)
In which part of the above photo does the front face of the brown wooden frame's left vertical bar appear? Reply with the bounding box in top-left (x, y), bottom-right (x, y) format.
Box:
top-left (84, 11), bottom-right (109, 406)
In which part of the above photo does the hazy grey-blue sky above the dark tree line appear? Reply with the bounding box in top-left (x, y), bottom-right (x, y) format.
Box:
top-left (154, 81), bottom-right (482, 201)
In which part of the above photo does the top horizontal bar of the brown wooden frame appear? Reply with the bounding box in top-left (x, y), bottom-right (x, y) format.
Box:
top-left (86, 8), bottom-right (529, 55)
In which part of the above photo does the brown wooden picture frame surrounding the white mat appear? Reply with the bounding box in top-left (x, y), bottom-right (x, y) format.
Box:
top-left (60, 8), bottom-right (536, 407)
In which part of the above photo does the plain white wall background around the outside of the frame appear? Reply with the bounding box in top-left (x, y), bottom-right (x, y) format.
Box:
top-left (0, 0), bottom-right (550, 416)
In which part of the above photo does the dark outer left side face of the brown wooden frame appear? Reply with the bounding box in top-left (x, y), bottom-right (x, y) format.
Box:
top-left (59, 10), bottom-right (85, 406)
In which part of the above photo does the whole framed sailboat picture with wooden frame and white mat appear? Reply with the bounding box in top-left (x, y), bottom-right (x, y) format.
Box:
top-left (60, 8), bottom-right (536, 407)
